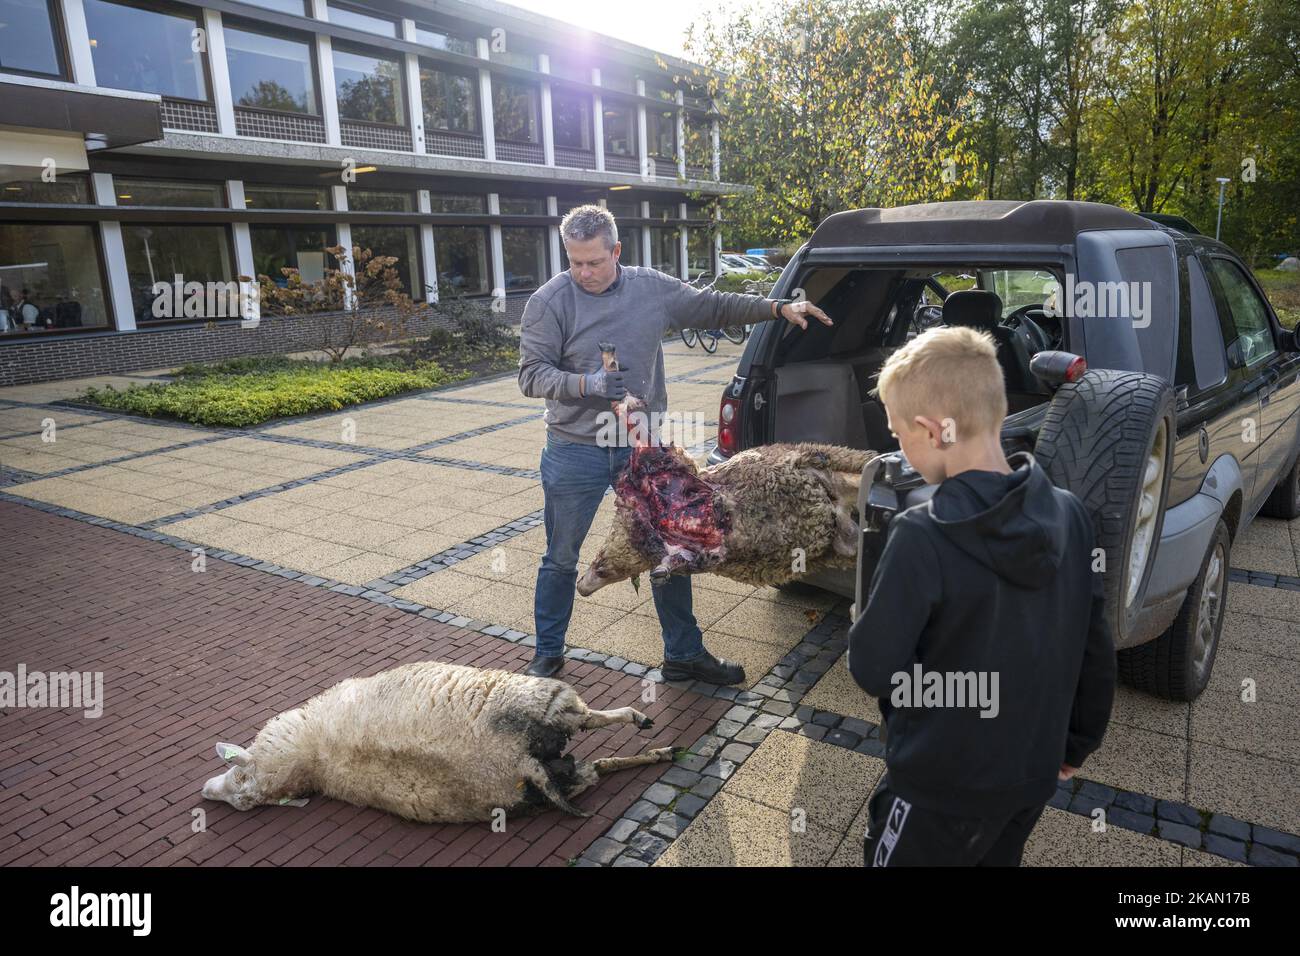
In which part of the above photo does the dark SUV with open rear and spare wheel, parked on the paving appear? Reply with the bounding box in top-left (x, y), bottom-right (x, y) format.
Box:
top-left (710, 200), bottom-right (1300, 700)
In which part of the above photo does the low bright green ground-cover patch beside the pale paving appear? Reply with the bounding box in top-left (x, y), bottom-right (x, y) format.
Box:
top-left (79, 356), bottom-right (469, 428)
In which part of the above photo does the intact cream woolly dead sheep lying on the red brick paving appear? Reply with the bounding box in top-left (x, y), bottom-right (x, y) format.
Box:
top-left (203, 661), bottom-right (673, 823)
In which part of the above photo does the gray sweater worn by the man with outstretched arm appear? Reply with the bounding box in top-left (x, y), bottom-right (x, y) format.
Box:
top-left (519, 265), bottom-right (772, 445)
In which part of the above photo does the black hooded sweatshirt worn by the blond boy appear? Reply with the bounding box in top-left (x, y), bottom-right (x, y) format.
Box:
top-left (849, 453), bottom-right (1115, 817)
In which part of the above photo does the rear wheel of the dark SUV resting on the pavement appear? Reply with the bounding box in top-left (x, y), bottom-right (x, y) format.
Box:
top-left (1118, 519), bottom-right (1232, 701)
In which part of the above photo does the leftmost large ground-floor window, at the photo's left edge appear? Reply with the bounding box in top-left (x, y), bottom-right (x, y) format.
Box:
top-left (0, 222), bottom-right (108, 336)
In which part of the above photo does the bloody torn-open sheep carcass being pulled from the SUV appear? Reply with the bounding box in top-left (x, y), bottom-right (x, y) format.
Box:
top-left (577, 442), bottom-right (876, 596)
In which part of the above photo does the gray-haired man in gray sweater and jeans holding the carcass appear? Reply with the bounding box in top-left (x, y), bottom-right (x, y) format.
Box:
top-left (519, 206), bottom-right (831, 684)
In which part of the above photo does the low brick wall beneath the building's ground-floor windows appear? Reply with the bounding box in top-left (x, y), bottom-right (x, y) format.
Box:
top-left (0, 295), bottom-right (528, 388)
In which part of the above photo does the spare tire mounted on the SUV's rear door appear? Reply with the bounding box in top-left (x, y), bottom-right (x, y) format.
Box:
top-left (1034, 369), bottom-right (1177, 648)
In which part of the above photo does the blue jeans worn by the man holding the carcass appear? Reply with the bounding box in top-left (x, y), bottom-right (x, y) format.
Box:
top-left (533, 437), bottom-right (705, 661)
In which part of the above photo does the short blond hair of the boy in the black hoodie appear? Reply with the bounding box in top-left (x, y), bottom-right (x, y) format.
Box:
top-left (875, 325), bottom-right (1006, 441)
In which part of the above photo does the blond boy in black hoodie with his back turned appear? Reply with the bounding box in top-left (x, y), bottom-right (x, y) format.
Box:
top-left (849, 326), bottom-right (1115, 866)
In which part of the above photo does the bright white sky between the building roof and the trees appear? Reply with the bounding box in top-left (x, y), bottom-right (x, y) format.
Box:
top-left (491, 0), bottom-right (757, 56)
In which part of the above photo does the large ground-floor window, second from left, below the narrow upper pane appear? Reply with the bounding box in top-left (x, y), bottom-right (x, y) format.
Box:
top-left (122, 222), bottom-right (238, 325)
